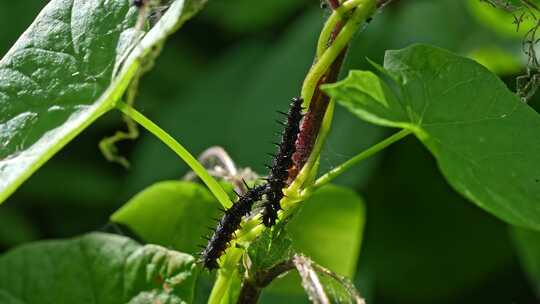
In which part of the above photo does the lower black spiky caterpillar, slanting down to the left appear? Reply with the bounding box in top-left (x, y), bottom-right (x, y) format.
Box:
top-left (200, 184), bottom-right (267, 270)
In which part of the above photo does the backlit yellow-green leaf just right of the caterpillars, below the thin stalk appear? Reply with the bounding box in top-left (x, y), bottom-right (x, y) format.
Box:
top-left (287, 185), bottom-right (365, 278)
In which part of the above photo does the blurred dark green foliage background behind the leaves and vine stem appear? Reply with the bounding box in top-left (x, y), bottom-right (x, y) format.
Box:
top-left (0, 0), bottom-right (540, 304)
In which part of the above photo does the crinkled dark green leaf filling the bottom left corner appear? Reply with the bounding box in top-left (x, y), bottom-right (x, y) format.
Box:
top-left (0, 233), bottom-right (196, 304)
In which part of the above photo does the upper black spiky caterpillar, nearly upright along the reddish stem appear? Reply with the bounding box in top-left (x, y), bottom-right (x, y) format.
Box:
top-left (262, 97), bottom-right (302, 227)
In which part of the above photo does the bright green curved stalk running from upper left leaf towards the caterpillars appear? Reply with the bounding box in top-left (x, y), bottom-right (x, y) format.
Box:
top-left (116, 101), bottom-right (232, 208)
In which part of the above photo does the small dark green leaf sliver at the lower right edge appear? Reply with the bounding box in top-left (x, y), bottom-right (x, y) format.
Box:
top-left (512, 228), bottom-right (540, 295)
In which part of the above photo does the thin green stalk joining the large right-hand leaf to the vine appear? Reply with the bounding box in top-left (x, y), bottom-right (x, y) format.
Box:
top-left (309, 129), bottom-right (411, 191)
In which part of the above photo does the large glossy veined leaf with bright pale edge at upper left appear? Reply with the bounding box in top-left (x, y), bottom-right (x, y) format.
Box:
top-left (0, 0), bottom-right (205, 202)
